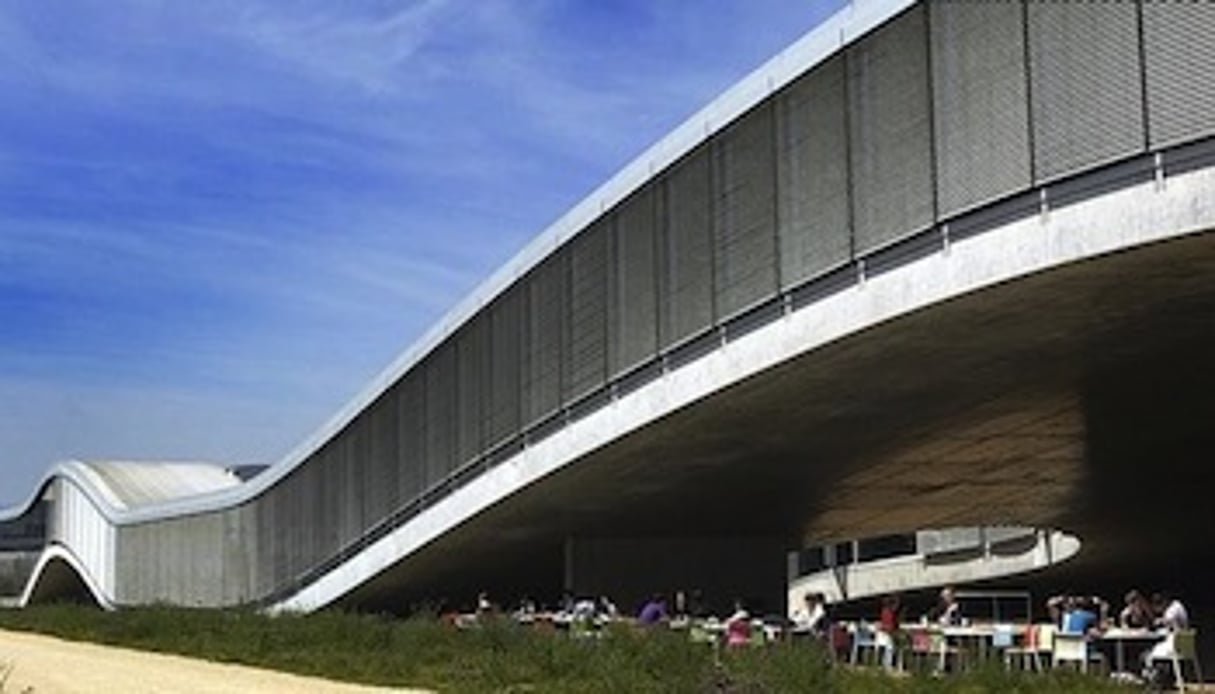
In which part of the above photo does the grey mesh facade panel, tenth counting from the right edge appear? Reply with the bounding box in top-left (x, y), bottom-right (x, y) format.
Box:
top-left (524, 253), bottom-right (567, 424)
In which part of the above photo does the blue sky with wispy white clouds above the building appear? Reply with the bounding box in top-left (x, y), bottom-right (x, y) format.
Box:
top-left (0, 0), bottom-right (844, 506)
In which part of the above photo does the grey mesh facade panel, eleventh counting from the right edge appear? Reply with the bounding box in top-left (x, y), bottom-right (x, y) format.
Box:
top-left (486, 284), bottom-right (526, 446)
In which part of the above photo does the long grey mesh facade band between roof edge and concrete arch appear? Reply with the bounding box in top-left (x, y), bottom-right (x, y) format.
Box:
top-left (99, 2), bottom-right (1215, 604)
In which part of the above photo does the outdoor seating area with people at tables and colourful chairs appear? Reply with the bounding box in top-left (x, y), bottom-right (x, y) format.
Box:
top-left (453, 587), bottom-right (1203, 690)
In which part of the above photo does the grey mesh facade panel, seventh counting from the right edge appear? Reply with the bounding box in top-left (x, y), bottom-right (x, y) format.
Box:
top-left (660, 146), bottom-right (713, 348)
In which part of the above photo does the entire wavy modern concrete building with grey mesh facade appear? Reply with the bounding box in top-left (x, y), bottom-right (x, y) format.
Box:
top-left (0, 0), bottom-right (1215, 619)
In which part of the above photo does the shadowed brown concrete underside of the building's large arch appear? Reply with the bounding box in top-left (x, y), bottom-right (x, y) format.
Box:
top-left (343, 232), bottom-right (1215, 616)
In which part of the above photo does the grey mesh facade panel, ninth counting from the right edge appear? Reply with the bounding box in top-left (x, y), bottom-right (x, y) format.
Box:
top-left (561, 222), bottom-right (610, 402)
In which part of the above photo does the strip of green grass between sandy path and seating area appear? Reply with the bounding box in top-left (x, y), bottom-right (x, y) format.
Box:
top-left (0, 605), bottom-right (1125, 694)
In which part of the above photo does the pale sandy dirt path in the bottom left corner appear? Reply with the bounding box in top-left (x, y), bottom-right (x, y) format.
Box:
top-left (0, 631), bottom-right (430, 694)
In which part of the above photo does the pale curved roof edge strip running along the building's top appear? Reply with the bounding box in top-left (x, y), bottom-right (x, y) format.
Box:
top-left (7, 0), bottom-right (919, 524)
